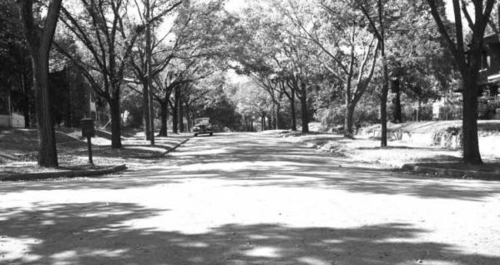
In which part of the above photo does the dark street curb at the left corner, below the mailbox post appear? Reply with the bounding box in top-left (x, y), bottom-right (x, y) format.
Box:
top-left (0, 165), bottom-right (127, 181)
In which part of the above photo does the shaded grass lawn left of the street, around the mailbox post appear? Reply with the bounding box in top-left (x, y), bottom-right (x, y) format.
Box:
top-left (0, 128), bottom-right (185, 174)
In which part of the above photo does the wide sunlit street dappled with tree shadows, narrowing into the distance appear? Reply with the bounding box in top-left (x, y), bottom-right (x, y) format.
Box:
top-left (0, 134), bottom-right (500, 265)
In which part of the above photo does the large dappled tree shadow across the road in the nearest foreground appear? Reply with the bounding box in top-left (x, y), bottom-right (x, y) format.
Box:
top-left (0, 202), bottom-right (500, 265)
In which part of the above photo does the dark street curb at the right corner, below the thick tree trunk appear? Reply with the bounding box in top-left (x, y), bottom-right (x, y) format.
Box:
top-left (401, 164), bottom-right (500, 180)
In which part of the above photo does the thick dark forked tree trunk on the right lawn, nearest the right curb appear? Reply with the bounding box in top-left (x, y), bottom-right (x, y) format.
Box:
top-left (427, 0), bottom-right (496, 164)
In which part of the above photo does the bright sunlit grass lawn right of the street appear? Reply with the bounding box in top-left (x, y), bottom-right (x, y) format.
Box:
top-left (274, 121), bottom-right (500, 179)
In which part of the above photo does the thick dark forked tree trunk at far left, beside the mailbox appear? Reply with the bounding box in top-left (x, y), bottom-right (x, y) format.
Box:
top-left (17, 0), bottom-right (62, 167)
